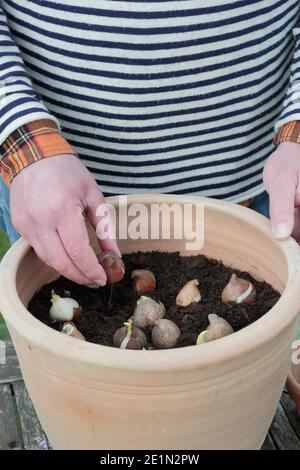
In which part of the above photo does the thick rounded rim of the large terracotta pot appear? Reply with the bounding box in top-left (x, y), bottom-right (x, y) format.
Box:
top-left (0, 194), bottom-right (300, 372)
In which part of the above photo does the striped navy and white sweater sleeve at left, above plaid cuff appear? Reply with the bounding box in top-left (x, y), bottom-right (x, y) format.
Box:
top-left (0, 4), bottom-right (59, 144)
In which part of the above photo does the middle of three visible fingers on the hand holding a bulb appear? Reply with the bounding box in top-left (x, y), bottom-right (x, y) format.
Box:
top-left (57, 206), bottom-right (107, 286)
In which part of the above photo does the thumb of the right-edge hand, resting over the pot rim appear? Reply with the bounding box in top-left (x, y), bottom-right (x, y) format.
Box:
top-left (269, 183), bottom-right (295, 240)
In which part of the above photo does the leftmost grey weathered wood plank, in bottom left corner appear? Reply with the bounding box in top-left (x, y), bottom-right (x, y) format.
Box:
top-left (0, 385), bottom-right (22, 450)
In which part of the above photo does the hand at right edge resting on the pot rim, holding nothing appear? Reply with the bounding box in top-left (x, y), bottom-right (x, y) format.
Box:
top-left (264, 142), bottom-right (300, 242)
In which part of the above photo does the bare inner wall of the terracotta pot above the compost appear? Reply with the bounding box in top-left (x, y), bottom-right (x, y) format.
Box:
top-left (16, 197), bottom-right (288, 312)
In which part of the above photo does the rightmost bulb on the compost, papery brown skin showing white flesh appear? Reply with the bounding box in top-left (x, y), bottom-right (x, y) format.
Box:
top-left (221, 274), bottom-right (257, 304)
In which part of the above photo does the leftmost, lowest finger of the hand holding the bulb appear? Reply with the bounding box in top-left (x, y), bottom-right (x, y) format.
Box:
top-left (31, 228), bottom-right (98, 287)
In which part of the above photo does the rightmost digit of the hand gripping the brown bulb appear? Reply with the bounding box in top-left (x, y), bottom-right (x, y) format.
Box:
top-left (86, 186), bottom-right (121, 254)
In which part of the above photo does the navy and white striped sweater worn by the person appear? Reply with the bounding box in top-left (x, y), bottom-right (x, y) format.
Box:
top-left (0, 0), bottom-right (300, 202)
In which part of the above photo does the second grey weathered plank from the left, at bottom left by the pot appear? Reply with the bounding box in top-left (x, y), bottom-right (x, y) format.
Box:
top-left (13, 382), bottom-right (48, 450)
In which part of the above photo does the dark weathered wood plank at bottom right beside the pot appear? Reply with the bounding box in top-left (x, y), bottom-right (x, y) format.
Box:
top-left (269, 403), bottom-right (300, 450)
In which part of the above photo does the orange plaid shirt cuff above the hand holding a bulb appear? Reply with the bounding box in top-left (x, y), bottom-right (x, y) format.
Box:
top-left (0, 119), bottom-right (75, 185)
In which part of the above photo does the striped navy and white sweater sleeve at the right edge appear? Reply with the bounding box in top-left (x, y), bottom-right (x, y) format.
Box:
top-left (275, 13), bottom-right (300, 130)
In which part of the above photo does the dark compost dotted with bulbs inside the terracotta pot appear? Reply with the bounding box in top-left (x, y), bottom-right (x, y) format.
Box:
top-left (28, 251), bottom-right (280, 350)
